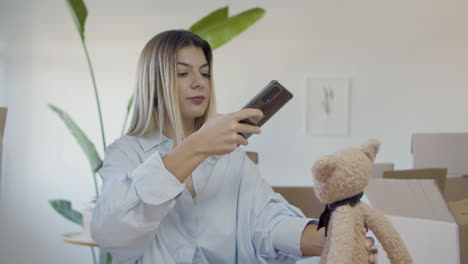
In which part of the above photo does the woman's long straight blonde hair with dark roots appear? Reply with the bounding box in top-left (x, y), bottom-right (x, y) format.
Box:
top-left (127, 30), bottom-right (215, 144)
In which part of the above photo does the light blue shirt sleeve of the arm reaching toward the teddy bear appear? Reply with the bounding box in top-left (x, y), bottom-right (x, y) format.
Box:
top-left (241, 151), bottom-right (317, 263)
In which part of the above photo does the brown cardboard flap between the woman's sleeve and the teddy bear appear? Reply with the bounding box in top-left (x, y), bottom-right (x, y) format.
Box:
top-left (273, 186), bottom-right (325, 218)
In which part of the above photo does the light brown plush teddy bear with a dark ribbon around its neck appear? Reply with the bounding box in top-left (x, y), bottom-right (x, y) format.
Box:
top-left (312, 139), bottom-right (413, 264)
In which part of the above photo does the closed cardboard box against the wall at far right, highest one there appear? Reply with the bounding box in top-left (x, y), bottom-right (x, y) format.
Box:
top-left (411, 133), bottom-right (468, 177)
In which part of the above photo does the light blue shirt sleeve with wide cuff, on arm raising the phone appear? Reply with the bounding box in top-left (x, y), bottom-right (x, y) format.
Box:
top-left (91, 141), bottom-right (184, 263)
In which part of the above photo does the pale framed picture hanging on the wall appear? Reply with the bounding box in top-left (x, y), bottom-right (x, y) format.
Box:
top-left (305, 78), bottom-right (350, 136)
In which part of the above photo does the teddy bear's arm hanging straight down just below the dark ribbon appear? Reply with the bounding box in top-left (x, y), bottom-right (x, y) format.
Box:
top-left (326, 206), bottom-right (354, 264)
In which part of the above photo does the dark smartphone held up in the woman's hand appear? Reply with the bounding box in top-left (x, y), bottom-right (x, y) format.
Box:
top-left (239, 80), bottom-right (293, 139)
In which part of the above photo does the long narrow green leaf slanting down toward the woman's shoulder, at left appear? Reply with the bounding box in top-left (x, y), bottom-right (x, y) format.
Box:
top-left (49, 104), bottom-right (102, 172)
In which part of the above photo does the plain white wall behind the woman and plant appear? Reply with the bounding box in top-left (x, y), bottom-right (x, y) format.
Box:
top-left (0, 0), bottom-right (468, 263)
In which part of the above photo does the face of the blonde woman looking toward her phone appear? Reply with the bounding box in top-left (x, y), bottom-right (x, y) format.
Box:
top-left (176, 46), bottom-right (211, 122)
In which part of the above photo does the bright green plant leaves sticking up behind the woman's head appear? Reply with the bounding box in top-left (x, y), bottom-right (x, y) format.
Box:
top-left (190, 7), bottom-right (265, 50)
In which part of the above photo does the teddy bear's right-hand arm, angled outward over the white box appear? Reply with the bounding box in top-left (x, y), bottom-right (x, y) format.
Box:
top-left (362, 204), bottom-right (413, 264)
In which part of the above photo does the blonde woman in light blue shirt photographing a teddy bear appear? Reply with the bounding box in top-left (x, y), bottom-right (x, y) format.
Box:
top-left (91, 30), bottom-right (373, 264)
